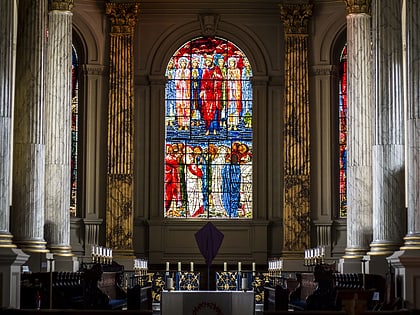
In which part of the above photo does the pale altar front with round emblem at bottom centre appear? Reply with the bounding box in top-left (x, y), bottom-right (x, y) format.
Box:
top-left (160, 291), bottom-right (255, 315)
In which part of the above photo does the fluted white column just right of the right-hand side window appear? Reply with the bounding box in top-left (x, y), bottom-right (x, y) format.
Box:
top-left (344, 0), bottom-right (372, 258)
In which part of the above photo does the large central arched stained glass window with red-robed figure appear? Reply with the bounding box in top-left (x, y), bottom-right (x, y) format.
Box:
top-left (164, 37), bottom-right (252, 219)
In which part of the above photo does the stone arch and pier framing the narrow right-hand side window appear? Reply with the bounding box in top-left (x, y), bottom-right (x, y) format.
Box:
top-left (310, 8), bottom-right (346, 256)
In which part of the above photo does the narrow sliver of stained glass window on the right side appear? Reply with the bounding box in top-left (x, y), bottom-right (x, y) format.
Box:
top-left (338, 46), bottom-right (347, 218)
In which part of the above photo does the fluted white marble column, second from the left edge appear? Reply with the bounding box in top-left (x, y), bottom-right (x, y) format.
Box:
top-left (11, 0), bottom-right (47, 252)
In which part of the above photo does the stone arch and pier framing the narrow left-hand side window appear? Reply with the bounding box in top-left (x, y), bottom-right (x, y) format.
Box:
top-left (70, 12), bottom-right (107, 255)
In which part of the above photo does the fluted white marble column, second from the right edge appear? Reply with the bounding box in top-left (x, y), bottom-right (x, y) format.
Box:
top-left (369, 0), bottom-right (405, 255)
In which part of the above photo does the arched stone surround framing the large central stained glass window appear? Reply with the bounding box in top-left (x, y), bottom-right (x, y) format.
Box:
top-left (135, 16), bottom-right (283, 263)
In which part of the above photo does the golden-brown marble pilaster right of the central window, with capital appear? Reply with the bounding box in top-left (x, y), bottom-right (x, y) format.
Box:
top-left (280, 4), bottom-right (312, 257)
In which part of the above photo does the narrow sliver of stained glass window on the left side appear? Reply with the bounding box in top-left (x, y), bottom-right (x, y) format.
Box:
top-left (70, 47), bottom-right (79, 216)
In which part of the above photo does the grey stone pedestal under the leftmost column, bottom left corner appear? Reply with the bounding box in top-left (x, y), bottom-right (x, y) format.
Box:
top-left (0, 247), bottom-right (29, 308)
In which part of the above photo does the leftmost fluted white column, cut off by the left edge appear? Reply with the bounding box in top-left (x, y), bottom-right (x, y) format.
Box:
top-left (0, 0), bottom-right (17, 247)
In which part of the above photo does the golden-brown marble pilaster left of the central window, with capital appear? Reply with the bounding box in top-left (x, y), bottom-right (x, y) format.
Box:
top-left (106, 2), bottom-right (140, 258)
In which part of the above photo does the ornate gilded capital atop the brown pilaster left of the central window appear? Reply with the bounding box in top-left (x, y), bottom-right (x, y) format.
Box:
top-left (106, 2), bottom-right (140, 34)
